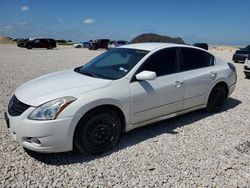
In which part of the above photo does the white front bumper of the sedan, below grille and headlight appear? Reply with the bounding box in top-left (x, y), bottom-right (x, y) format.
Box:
top-left (5, 108), bottom-right (73, 153)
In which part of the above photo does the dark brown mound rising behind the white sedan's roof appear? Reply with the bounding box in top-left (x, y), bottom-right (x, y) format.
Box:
top-left (131, 33), bottom-right (185, 44)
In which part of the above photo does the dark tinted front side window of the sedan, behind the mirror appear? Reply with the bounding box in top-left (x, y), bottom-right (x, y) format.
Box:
top-left (140, 48), bottom-right (178, 77)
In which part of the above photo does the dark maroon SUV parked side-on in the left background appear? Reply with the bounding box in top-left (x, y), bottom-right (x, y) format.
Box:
top-left (23, 38), bottom-right (56, 49)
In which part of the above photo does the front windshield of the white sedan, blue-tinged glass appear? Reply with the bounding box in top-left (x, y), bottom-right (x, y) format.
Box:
top-left (75, 48), bottom-right (148, 80)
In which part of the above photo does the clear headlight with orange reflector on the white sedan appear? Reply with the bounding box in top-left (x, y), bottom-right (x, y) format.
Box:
top-left (28, 97), bottom-right (76, 120)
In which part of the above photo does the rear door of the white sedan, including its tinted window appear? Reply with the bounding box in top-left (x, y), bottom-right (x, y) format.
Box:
top-left (180, 47), bottom-right (217, 109)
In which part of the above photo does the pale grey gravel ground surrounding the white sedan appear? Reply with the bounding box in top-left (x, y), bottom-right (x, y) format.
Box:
top-left (0, 45), bottom-right (250, 187)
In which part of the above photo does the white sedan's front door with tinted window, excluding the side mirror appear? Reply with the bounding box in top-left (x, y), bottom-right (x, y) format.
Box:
top-left (130, 48), bottom-right (184, 124)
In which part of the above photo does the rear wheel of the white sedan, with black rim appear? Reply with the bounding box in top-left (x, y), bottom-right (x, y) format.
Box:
top-left (206, 85), bottom-right (227, 112)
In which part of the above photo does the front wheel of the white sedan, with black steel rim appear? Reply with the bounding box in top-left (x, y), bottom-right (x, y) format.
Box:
top-left (74, 108), bottom-right (121, 155)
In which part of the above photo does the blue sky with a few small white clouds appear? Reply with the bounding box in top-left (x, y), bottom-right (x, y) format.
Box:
top-left (0, 0), bottom-right (250, 45)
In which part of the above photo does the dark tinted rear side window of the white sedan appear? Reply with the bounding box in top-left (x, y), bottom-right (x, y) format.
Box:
top-left (180, 48), bottom-right (214, 71)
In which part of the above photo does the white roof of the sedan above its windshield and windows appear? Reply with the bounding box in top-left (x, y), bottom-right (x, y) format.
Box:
top-left (118, 42), bottom-right (195, 51)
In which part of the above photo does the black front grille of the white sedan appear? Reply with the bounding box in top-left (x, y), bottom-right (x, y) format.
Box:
top-left (8, 95), bottom-right (30, 116)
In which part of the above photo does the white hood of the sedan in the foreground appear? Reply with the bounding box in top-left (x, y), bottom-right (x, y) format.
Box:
top-left (15, 69), bottom-right (112, 106)
